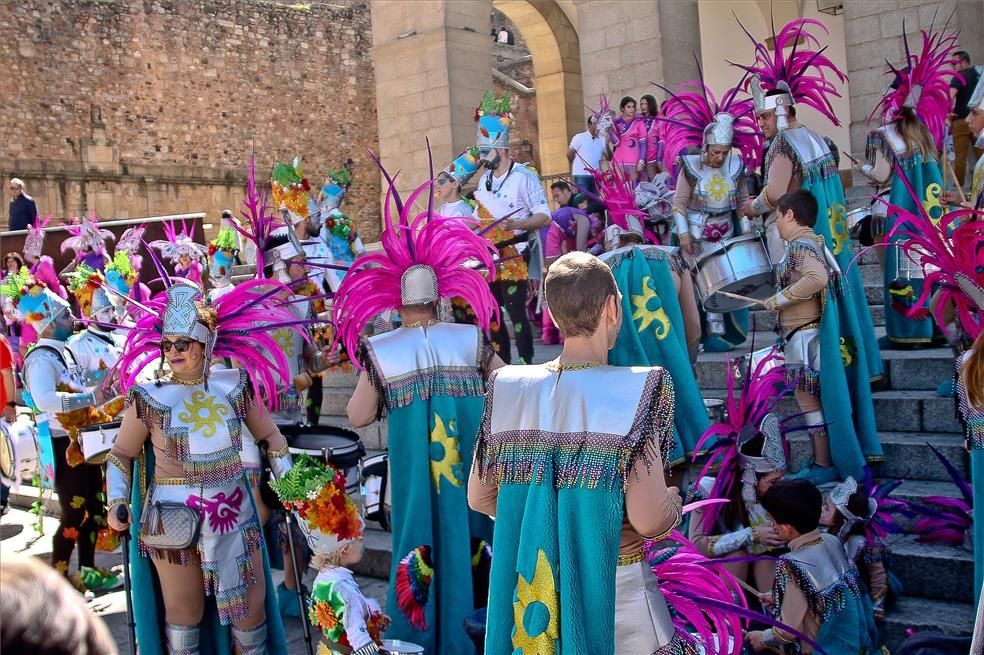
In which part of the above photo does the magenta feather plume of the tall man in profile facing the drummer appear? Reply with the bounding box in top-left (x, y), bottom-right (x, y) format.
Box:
top-left (728, 17), bottom-right (847, 125)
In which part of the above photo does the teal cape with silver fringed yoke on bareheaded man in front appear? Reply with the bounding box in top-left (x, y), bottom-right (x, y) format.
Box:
top-left (475, 366), bottom-right (673, 655)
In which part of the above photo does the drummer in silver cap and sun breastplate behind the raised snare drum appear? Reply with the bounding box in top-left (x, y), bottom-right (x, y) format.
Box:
top-left (664, 105), bottom-right (757, 352)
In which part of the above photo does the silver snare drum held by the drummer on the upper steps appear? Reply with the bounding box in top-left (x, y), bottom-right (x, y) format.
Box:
top-left (693, 235), bottom-right (776, 313)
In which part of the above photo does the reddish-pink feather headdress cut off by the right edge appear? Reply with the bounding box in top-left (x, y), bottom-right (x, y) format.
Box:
top-left (886, 166), bottom-right (984, 339)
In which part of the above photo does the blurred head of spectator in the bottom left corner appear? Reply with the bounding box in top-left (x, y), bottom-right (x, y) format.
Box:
top-left (0, 556), bottom-right (117, 655)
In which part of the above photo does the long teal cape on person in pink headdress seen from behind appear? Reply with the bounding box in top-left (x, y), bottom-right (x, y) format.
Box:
top-left (360, 324), bottom-right (493, 655)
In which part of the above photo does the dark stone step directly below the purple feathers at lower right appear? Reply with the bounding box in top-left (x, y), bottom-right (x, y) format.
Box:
top-left (889, 536), bottom-right (974, 603)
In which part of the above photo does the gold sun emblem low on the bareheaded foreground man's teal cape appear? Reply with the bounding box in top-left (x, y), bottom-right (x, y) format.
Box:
top-left (513, 550), bottom-right (560, 655)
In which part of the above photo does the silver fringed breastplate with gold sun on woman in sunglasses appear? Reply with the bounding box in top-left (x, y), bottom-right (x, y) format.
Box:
top-left (130, 369), bottom-right (249, 487)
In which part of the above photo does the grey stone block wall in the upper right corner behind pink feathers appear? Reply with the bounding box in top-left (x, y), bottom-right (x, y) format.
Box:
top-left (844, 0), bottom-right (984, 163)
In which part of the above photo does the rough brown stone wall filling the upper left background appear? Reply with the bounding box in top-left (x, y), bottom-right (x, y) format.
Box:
top-left (0, 0), bottom-right (379, 240)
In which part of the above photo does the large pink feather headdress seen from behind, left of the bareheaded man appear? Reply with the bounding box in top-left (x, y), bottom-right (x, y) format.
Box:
top-left (334, 171), bottom-right (498, 364)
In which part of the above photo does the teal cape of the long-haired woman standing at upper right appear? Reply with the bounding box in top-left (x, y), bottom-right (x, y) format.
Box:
top-left (867, 130), bottom-right (943, 345)
